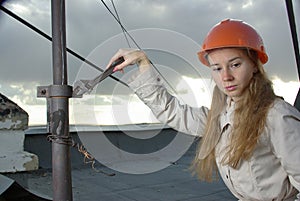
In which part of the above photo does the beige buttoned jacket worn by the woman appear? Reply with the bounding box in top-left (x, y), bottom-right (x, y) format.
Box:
top-left (128, 66), bottom-right (300, 201)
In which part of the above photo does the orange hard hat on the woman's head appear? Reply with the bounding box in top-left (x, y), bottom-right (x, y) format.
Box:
top-left (198, 19), bottom-right (268, 66)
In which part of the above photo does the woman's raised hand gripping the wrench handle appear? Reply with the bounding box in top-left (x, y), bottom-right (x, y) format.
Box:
top-left (106, 49), bottom-right (150, 72)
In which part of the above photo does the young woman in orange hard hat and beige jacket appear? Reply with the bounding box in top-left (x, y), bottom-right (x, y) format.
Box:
top-left (109, 19), bottom-right (300, 201)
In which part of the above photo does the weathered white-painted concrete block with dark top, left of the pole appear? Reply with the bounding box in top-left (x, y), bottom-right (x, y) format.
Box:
top-left (0, 93), bottom-right (39, 173)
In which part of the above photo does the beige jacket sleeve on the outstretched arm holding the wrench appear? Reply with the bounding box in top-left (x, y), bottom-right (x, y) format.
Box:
top-left (128, 68), bottom-right (208, 136)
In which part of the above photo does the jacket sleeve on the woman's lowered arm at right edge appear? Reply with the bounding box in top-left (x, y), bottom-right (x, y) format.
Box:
top-left (270, 100), bottom-right (300, 191)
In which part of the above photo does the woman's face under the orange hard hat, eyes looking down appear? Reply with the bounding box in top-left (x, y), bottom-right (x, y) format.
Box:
top-left (207, 48), bottom-right (257, 101)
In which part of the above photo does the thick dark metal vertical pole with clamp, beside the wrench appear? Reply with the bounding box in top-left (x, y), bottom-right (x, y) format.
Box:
top-left (49, 0), bottom-right (72, 201)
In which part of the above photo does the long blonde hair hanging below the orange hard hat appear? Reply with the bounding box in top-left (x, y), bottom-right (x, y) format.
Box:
top-left (191, 50), bottom-right (276, 181)
